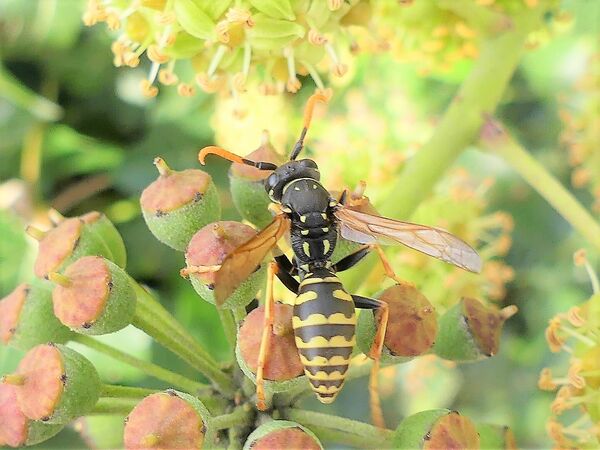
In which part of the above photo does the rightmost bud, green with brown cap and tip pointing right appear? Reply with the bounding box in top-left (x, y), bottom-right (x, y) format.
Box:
top-left (433, 297), bottom-right (517, 361)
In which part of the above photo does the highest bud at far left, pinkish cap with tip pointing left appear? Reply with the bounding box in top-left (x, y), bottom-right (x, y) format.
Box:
top-left (27, 212), bottom-right (125, 279)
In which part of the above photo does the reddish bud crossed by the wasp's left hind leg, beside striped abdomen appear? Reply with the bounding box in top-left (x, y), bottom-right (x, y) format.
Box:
top-left (236, 303), bottom-right (306, 393)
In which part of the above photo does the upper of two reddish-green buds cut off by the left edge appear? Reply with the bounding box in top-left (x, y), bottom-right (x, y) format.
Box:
top-left (0, 284), bottom-right (71, 350)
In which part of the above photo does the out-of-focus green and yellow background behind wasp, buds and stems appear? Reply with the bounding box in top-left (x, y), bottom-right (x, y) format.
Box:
top-left (0, 0), bottom-right (600, 448)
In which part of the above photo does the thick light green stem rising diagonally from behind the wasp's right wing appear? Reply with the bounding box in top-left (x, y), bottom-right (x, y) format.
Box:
top-left (346, 5), bottom-right (545, 292)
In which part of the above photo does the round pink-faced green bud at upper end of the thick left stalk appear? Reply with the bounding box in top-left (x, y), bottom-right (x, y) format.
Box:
top-left (50, 256), bottom-right (136, 335)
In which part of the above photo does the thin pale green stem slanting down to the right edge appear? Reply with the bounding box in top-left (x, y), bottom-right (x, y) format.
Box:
top-left (481, 119), bottom-right (600, 249)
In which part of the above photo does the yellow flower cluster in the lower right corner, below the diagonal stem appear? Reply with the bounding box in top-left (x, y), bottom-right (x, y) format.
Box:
top-left (538, 250), bottom-right (600, 449)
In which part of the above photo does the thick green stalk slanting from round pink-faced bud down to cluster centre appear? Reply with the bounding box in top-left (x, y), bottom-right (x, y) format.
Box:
top-left (132, 302), bottom-right (234, 395)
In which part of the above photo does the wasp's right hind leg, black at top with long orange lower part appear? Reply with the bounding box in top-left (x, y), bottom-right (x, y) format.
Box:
top-left (352, 295), bottom-right (389, 428)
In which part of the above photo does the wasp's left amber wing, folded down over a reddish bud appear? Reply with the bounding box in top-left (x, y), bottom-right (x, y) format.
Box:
top-left (214, 214), bottom-right (290, 306)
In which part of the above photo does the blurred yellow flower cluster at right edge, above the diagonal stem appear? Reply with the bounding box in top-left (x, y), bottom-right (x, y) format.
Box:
top-left (559, 53), bottom-right (600, 212)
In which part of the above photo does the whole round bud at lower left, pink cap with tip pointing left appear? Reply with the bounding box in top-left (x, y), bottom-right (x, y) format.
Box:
top-left (2, 344), bottom-right (101, 424)
